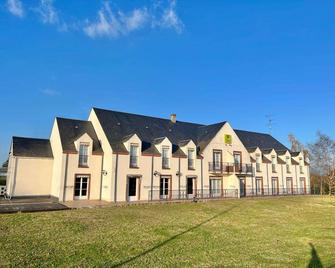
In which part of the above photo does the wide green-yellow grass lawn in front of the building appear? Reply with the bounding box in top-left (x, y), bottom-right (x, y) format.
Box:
top-left (0, 197), bottom-right (335, 267)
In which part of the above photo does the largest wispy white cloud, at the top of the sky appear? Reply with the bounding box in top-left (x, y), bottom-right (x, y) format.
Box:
top-left (83, 0), bottom-right (184, 38)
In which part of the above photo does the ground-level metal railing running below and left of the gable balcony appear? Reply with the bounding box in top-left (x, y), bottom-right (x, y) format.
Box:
top-left (148, 189), bottom-right (238, 201)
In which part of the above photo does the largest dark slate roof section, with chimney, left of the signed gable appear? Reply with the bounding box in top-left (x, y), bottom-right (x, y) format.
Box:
top-left (93, 108), bottom-right (225, 156)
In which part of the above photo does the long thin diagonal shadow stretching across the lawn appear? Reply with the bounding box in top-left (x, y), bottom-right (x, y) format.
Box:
top-left (111, 205), bottom-right (239, 267)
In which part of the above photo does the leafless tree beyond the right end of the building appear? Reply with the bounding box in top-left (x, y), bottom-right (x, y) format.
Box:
top-left (308, 132), bottom-right (335, 195)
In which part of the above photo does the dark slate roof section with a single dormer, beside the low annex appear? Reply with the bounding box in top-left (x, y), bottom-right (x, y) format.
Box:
top-left (56, 117), bottom-right (103, 154)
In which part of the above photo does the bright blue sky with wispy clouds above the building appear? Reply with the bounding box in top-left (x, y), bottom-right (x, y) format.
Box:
top-left (0, 0), bottom-right (335, 160)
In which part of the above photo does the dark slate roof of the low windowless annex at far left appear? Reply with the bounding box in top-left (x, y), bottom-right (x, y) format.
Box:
top-left (12, 137), bottom-right (53, 158)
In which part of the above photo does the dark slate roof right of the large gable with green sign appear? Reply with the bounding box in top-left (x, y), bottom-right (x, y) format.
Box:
top-left (235, 130), bottom-right (288, 151)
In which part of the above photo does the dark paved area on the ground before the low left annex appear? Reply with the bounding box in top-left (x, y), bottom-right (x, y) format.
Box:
top-left (0, 198), bottom-right (69, 214)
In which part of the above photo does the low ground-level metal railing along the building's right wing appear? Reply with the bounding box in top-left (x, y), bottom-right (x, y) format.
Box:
top-left (240, 187), bottom-right (310, 197)
